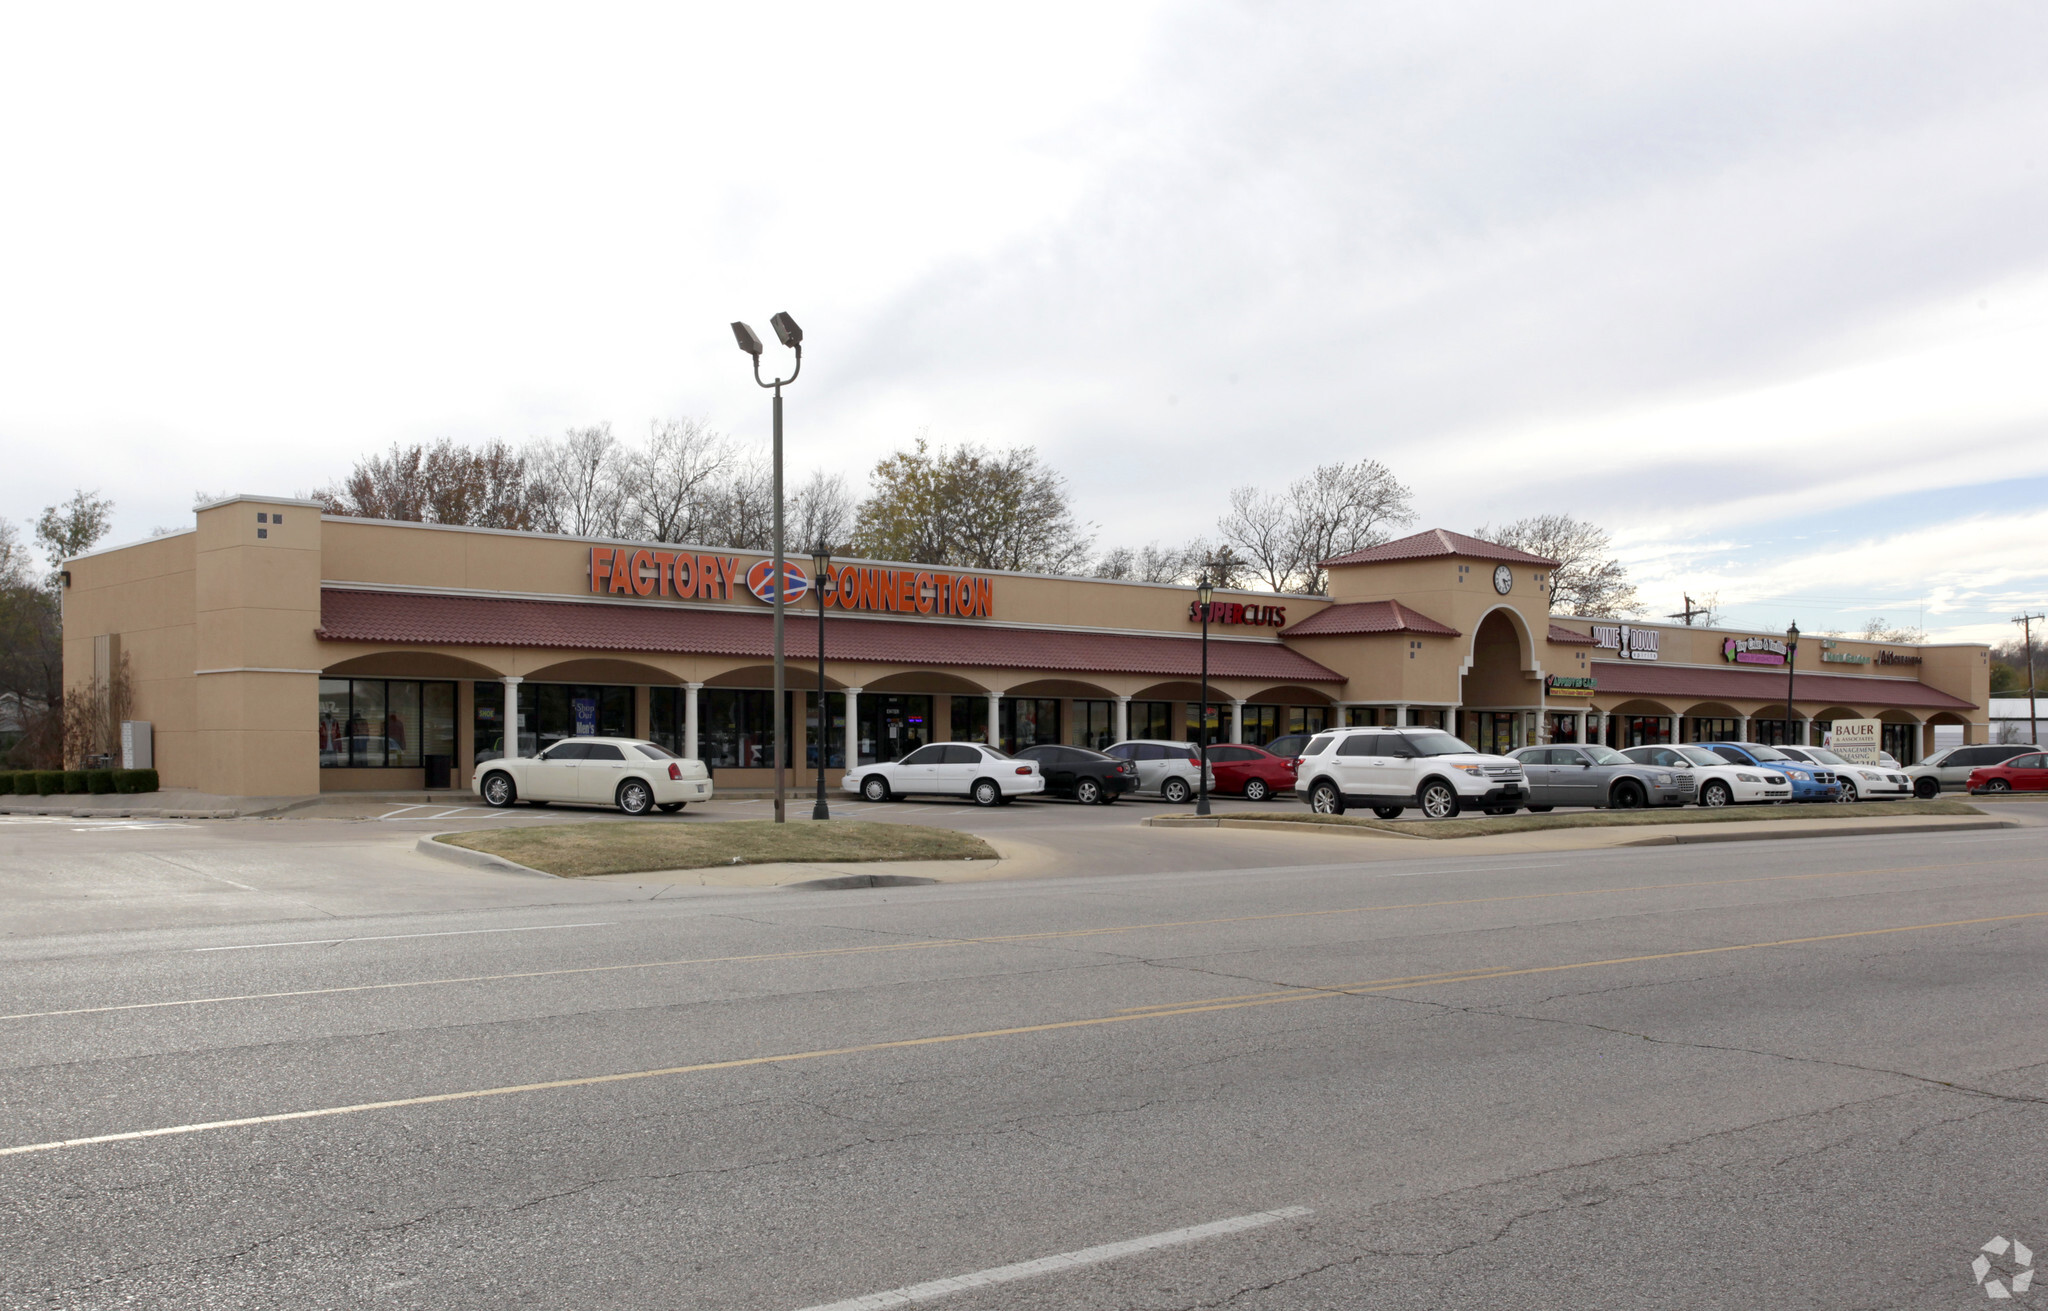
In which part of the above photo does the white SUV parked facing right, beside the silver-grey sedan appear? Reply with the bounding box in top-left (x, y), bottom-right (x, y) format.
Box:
top-left (1294, 729), bottom-right (1530, 819)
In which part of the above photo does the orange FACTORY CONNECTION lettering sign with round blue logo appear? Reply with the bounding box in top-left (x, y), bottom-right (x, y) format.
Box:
top-left (590, 547), bottom-right (995, 619)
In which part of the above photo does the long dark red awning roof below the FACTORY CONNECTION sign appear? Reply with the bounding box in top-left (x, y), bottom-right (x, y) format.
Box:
top-left (317, 588), bottom-right (1343, 682)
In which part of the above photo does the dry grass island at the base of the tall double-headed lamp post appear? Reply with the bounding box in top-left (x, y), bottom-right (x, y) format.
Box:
top-left (436, 819), bottom-right (995, 879)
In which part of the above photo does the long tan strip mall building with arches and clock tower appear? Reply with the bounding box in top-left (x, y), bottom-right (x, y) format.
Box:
top-left (63, 496), bottom-right (1991, 795)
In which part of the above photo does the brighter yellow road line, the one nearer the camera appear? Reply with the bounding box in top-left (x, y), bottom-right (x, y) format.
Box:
top-left (0, 910), bottom-right (2048, 1155)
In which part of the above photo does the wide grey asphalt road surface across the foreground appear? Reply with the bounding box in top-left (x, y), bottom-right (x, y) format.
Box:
top-left (0, 807), bottom-right (2048, 1311)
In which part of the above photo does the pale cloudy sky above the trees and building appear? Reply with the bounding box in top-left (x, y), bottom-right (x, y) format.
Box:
top-left (0, 0), bottom-right (2048, 639)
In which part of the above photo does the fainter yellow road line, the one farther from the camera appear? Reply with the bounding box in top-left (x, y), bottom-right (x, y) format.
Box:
top-left (0, 860), bottom-right (2011, 1022)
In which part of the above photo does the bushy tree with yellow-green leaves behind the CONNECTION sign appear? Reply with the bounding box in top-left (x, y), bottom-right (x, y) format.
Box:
top-left (852, 436), bottom-right (1094, 574)
